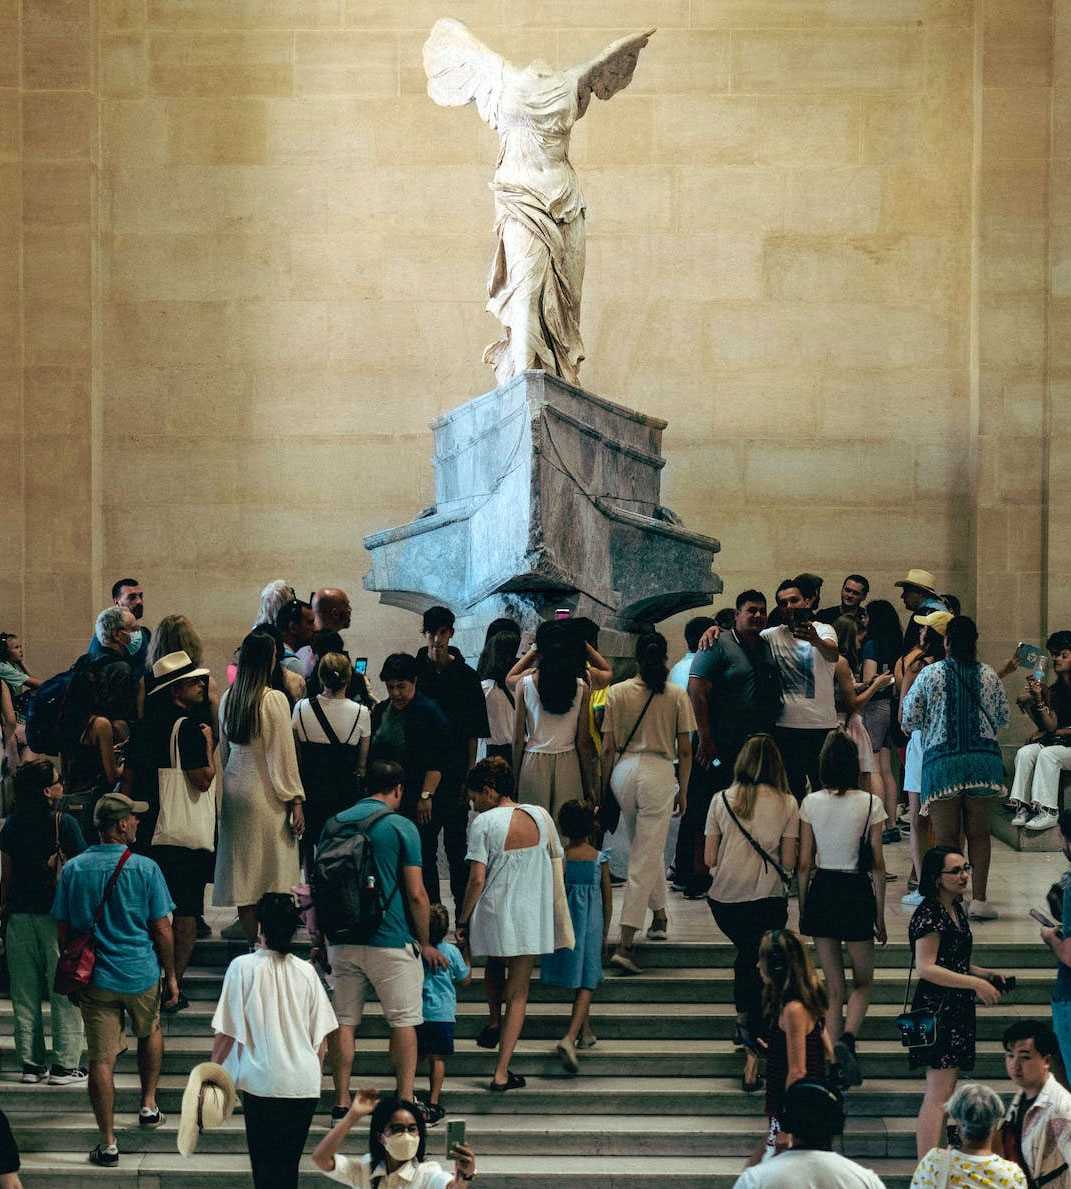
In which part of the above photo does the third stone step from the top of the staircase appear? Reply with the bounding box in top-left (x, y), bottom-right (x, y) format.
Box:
top-left (0, 995), bottom-right (1047, 1042)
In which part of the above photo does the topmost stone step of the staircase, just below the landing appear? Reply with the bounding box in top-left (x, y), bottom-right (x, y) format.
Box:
top-left (181, 941), bottom-right (1054, 970)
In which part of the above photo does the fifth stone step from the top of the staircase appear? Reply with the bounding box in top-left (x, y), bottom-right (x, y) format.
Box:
top-left (0, 1072), bottom-right (1012, 1119)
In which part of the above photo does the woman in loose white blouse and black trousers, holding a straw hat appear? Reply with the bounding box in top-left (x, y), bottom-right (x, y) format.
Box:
top-left (212, 892), bottom-right (339, 1189)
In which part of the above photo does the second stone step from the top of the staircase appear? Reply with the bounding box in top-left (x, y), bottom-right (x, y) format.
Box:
top-left (182, 955), bottom-right (1053, 1005)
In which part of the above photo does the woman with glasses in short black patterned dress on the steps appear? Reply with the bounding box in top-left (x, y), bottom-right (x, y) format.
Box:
top-left (907, 847), bottom-right (1003, 1159)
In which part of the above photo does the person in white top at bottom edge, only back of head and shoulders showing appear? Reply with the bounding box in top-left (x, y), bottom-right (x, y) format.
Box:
top-left (733, 1077), bottom-right (884, 1189)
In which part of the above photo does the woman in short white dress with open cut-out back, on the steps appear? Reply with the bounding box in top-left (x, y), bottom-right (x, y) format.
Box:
top-left (458, 757), bottom-right (563, 1092)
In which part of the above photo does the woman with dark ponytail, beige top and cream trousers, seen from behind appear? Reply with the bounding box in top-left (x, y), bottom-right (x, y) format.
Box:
top-left (603, 631), bottom-right (695, 974)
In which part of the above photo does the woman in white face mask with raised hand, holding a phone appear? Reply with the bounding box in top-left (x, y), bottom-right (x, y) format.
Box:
top-left (313, 1090), bottom-right (475, 1189)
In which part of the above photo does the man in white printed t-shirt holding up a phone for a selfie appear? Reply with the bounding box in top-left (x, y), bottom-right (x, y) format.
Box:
top-left (762, 574), bottom-right (839, 801)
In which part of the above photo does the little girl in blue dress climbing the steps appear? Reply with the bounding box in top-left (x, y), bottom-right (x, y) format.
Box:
top-left (540, 801), bottom-right (613, 1074)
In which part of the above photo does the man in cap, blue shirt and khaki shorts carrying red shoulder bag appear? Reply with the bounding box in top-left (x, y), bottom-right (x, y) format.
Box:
top-left (52, 793), bottom-right (178, 1168)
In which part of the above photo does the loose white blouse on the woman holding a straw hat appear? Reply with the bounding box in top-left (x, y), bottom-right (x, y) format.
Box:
top-left (212, 950), bottom-right (339, 1099)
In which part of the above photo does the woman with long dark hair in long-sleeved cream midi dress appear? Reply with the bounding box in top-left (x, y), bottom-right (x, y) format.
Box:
top-left (212, 631), bottom-right (305, 943)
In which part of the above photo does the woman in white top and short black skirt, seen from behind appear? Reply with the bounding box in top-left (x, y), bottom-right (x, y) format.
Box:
top-left (800, 730), bottom-right (888, 1086)
